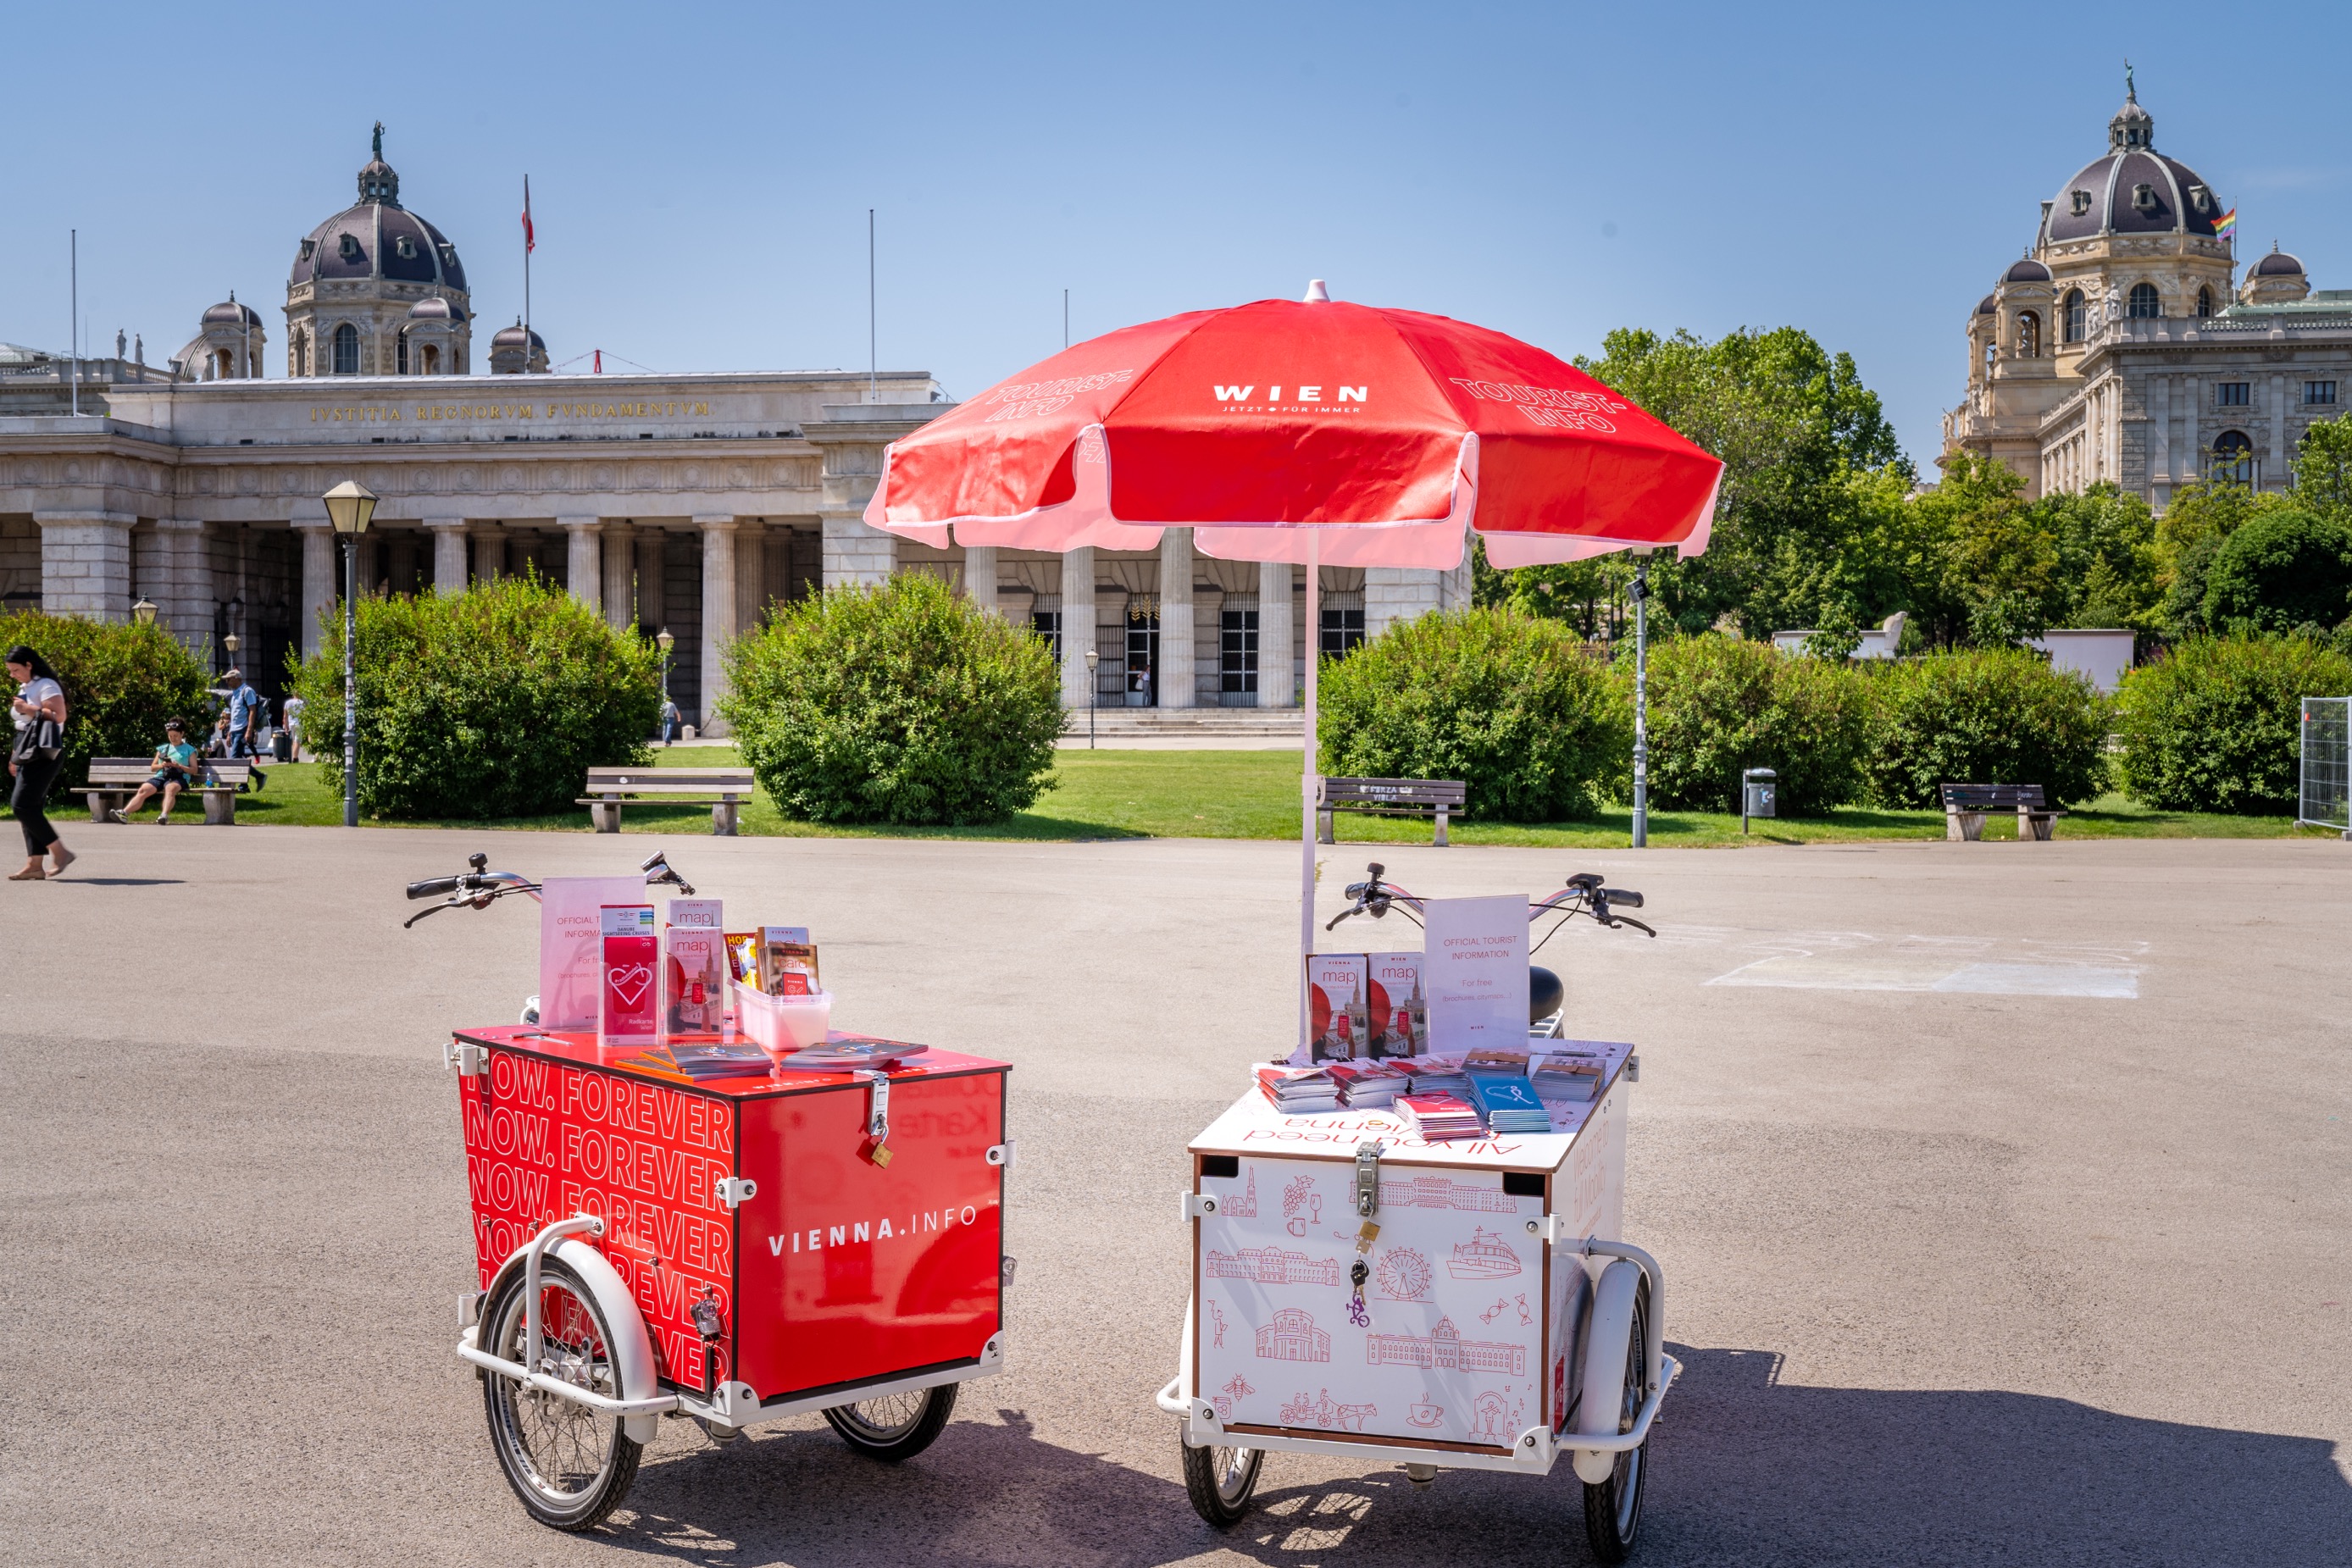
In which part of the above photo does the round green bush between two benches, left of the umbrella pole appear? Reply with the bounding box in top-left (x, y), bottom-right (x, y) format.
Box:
top-left (718, 571), bottom-right (1066, 825)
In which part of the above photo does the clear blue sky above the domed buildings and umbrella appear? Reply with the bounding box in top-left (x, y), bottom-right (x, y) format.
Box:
top-left (0, 3), bottom-right (2352, 465)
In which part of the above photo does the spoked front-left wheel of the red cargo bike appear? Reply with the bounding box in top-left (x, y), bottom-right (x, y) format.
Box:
top-left (482, 1258), bottom-right (645, 1531)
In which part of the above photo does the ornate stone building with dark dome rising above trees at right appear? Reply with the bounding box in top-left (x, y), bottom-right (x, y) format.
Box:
top-left (1943, 91), bottom-right (2352, 510)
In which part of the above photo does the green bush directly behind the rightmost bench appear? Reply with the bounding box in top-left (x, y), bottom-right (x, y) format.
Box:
top-left (1865, 649), bottom-right (2110, 806)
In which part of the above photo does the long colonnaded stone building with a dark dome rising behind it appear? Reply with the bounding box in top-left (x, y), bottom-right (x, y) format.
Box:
top-left (0, 127), bottom-right (1470, 734)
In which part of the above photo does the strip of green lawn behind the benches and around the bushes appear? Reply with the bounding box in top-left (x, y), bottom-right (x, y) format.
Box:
top-left (141, 745), bottom-right (2324, 849)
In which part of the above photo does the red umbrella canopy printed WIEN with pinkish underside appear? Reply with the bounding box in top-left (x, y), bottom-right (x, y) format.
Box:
top-left (866, 282), bottom-right (1724, 571)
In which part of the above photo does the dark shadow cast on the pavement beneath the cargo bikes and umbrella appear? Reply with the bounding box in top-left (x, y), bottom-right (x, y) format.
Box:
top-left (574, 1347), bottom-right (2352, 1568)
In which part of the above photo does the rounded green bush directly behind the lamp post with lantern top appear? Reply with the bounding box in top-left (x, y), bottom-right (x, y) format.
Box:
top-left (291, 576), bottom-right (661, 821)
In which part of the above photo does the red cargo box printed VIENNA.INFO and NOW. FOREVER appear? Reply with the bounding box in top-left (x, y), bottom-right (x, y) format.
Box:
top-left (457, 1025), bottom-right (1009, 1404)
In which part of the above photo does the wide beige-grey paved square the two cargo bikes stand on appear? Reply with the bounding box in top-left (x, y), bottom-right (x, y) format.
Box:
top-left (0, 825), bottom-right (2352, 1568)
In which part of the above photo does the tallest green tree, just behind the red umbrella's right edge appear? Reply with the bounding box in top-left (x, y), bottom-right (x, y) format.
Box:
top-left (1571, 327), bottom-right (1910, 637)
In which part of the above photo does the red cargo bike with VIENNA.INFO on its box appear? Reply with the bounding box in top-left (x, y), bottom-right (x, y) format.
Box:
top-left (409, 856), bottom-right (1012, 1531)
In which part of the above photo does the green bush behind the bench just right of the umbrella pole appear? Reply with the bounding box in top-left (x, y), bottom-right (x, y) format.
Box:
top-left (1317, 607), bottom-right (1633, 823)
